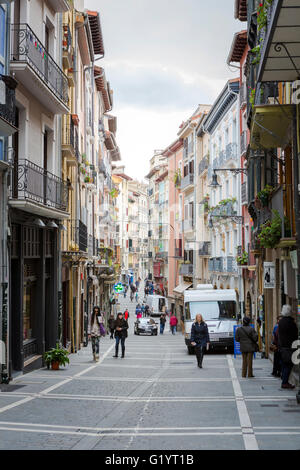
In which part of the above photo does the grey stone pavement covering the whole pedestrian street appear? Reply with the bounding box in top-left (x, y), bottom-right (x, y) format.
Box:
top-left (0, 284), bottom-right (300, 451)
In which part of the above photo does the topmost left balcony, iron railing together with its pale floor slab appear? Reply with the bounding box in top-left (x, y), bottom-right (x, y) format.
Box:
top-left (11, 23), bottom-right (69, 114)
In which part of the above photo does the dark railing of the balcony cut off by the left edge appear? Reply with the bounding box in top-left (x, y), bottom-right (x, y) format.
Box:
top-left (0, 75), bottom-right (17, 135)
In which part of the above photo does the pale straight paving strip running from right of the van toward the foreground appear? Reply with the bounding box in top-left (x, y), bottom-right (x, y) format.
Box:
top-left (227, 354), bottom-right (259, 450)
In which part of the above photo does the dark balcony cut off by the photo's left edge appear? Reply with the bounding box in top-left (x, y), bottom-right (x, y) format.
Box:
top-left (0, 75), bottom-right (17, 137)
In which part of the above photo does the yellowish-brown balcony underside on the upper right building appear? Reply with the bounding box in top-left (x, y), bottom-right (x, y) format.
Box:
top-left (250, 104), bottom-right (294, 150)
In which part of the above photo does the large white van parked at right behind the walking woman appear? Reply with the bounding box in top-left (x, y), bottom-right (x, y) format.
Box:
top-left (184, 284), bottom-right (239, 354)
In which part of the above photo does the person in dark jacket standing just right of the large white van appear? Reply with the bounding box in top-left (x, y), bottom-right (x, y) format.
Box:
top-left (235, 317), bottom-right (258, 377)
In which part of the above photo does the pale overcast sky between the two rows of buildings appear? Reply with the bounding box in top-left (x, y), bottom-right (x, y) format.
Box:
top-left (85, 0), bottom-right (244, 180)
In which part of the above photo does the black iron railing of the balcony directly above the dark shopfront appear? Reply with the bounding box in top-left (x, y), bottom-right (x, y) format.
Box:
top-left (11, 159), bottom-right (68, 211)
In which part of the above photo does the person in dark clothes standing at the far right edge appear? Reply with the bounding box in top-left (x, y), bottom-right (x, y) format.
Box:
top-left (278, 305), bottom-right (298, 389)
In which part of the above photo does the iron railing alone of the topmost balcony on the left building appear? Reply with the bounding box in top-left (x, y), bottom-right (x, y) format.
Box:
top-left (11, 23), bottom-right (69, 105)
